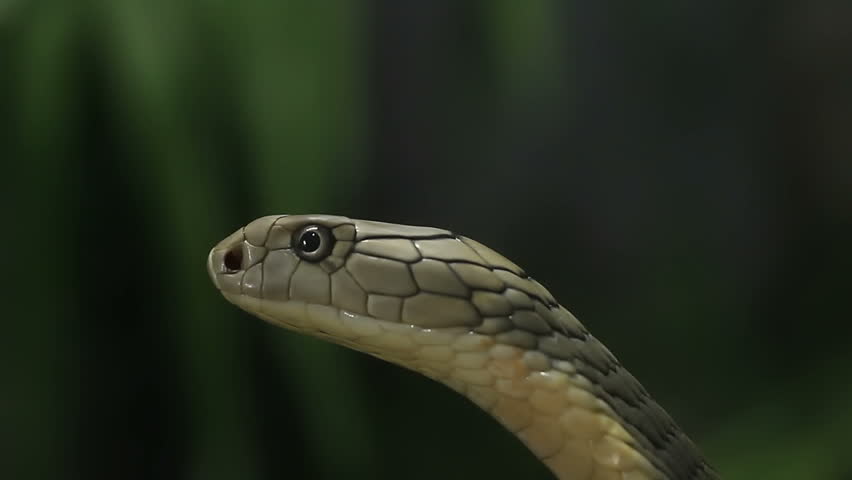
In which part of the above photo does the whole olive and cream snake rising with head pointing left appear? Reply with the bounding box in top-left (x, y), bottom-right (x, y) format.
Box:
top-left (207, 215), bottom-right (719, 480)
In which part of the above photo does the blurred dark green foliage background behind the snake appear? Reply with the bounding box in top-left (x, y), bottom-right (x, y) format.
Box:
top-left (0, 0), bottom-right (852, 480)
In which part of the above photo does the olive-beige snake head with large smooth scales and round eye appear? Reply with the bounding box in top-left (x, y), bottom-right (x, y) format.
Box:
top-left (207, 215), bottom-right (556, 354)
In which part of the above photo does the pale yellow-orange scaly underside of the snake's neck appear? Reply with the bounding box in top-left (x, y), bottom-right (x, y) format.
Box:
top-left (361, 318), bottom-right (666, 480)
